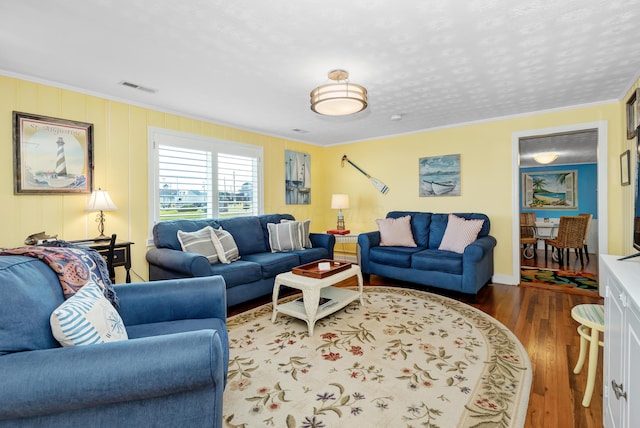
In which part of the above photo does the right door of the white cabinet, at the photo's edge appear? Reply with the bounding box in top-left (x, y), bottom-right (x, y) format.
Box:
top-left (620, 305), bottom-right (640, 427)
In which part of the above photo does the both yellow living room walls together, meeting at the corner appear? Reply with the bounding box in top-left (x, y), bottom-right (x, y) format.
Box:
top-left (0, 76), bottom-right (638, 280)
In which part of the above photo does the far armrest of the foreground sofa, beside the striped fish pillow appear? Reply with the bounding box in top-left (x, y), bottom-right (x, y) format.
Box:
top-left (114, 275), bottom-right (227, 326)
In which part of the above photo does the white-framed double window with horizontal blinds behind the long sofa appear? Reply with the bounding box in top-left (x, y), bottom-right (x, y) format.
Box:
top-left (149, 128), bottom-right (263, 234)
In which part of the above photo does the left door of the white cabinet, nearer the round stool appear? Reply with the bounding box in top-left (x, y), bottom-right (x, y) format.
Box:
top-left (603, 280), bottom-right (627, 428)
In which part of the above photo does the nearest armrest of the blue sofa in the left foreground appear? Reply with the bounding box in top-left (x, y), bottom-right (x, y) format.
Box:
top-left (0, 330), bottom-right (224, 420)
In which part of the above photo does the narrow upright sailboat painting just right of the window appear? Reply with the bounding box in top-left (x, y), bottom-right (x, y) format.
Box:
top-left (284, 150), bottom-right (311, 205)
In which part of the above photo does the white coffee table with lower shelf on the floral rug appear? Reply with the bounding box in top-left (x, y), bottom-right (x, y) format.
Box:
top-left (271, 265), bottom-right (364, 336)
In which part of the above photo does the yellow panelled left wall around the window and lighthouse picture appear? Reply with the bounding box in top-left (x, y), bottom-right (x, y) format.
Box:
top-left (0, 76), bottom-right (326, 281)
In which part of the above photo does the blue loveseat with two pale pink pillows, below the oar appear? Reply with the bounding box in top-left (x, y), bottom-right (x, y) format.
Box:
top-left (358, 211), bottom-right (496, 296)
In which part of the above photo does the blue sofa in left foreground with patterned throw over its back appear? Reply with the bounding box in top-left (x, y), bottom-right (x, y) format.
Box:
top-left (0, 256), bottom-right (229, 428)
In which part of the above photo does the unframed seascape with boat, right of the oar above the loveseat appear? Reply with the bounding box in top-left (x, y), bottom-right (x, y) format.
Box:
top-left (418, 154), bottom-right (460, 197)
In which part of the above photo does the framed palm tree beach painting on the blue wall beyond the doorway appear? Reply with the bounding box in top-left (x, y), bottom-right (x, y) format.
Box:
top-left (522, 170), bottom-right (578, 210)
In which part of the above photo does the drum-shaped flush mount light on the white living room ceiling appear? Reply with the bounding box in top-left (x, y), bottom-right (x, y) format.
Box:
top-left (311, 70), bottom-right (367, 116)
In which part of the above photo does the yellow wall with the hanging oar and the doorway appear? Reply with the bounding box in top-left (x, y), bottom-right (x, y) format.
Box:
top-left (323, 103), bottom-right (630, 276)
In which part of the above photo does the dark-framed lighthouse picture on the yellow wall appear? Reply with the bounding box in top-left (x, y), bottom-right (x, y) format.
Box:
top-left (13, 111), bottom-right (93, 194)
